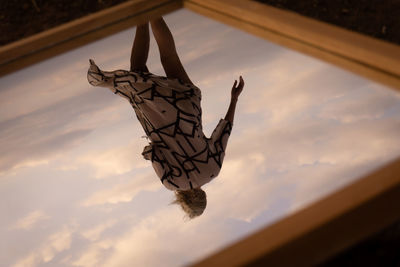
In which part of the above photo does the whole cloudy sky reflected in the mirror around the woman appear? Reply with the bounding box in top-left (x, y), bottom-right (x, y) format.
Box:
top-left (0, 10), bottom-right (400, 266)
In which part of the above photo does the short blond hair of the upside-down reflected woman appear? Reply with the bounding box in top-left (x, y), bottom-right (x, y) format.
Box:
top-left (172, 188), bottom-right (207, 219)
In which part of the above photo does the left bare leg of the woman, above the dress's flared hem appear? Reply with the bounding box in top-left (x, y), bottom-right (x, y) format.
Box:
top-left (131, 22), bottom-right (150, 71)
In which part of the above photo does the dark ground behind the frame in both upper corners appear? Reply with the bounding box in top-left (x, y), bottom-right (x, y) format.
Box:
top-left (0, 0), bottom-right (400, 46)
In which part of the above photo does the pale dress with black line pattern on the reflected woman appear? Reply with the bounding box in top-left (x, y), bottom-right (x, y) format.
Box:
top-left (88, 60), bottom-right (232, 190)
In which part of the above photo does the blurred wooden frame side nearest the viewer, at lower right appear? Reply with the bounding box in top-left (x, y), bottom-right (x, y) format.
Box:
top-left (191, 158), bottom-right (400, 267)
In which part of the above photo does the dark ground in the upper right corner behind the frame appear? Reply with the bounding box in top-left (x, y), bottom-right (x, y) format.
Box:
top-left (256, 0), bottom-right (400, 44)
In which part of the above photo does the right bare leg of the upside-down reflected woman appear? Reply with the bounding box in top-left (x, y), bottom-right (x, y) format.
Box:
top-left (150, 18), bottom-right (192, 83)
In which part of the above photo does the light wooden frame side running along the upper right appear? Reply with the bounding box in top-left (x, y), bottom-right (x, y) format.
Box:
top-left (184, 0), bottom-right (400, 90)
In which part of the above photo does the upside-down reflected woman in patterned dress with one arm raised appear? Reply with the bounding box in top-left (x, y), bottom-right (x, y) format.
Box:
top-left (88, 18), bottom-right (244, 218)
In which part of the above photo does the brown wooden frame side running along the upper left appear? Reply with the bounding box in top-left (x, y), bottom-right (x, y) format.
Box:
top-left (0, 0), bottom-right (183, 77)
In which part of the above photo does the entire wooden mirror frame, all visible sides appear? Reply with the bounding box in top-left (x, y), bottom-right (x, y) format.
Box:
top-left (0, 0), bottom-right (400, 267)
